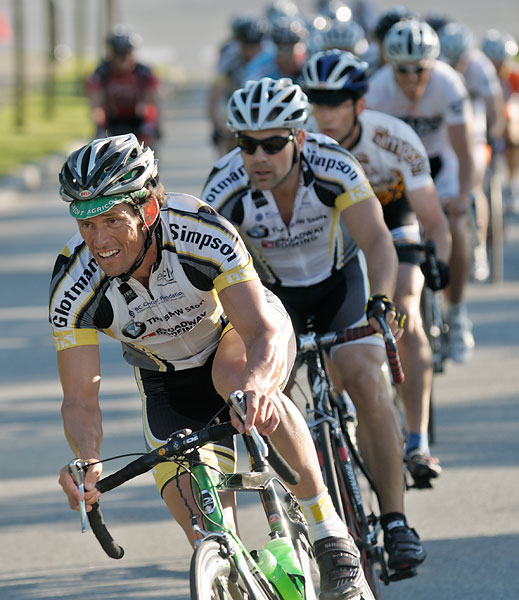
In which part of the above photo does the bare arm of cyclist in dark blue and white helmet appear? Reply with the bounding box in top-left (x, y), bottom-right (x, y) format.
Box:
top-left (406, 182), bottom-right (451, 263)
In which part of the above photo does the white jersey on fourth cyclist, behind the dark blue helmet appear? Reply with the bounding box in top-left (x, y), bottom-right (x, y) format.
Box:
top-left (366, 61), bottom-right (472, 197)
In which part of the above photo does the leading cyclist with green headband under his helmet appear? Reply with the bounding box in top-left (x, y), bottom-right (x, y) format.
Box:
top-left (50, 135), bottom-right (365, 600)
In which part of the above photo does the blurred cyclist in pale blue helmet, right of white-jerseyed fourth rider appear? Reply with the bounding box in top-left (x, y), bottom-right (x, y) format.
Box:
top-left (438, 22), bottom-right (505, 281)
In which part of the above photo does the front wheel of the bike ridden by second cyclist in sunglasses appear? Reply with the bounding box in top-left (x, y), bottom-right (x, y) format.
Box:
top-left (331, 431), bottom-right (383, 600)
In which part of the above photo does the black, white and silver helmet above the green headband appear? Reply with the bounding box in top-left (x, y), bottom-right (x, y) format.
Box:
top-left (59, 133), bottom-right (158, 202)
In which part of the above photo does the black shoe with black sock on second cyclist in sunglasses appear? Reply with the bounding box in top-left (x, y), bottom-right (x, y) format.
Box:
top-left (384, 520), bottom-right (426, 571)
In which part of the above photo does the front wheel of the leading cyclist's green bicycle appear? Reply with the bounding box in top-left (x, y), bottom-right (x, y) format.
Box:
top-left (189, 539), bottom-right (278, 600)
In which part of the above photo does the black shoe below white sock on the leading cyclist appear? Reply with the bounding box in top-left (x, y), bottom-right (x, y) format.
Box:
top-left (314, 536), bottom-right (365, 600)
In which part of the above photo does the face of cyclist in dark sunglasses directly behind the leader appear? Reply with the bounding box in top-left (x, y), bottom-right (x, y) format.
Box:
top-left (241, 129), bottom-right (305, 190)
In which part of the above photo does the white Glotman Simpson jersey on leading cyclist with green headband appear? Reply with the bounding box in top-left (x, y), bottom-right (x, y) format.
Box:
top-left (49, 194), bottom-right (258, 371)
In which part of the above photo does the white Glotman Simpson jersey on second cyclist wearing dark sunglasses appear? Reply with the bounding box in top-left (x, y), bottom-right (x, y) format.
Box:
top-left (202, 134), bottom-right (373, 287)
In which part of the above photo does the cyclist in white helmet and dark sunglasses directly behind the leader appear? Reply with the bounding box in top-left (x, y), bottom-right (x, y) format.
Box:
top-left (202, 78), bottom-right (425, 570)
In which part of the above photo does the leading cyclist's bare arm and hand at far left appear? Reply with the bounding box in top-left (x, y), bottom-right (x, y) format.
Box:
top-left (58, 345), bottom-right (103, 510)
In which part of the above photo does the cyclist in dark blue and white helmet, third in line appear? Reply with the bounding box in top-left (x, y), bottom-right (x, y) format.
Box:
top-left (302, 50), bottom-right (450, 487)
